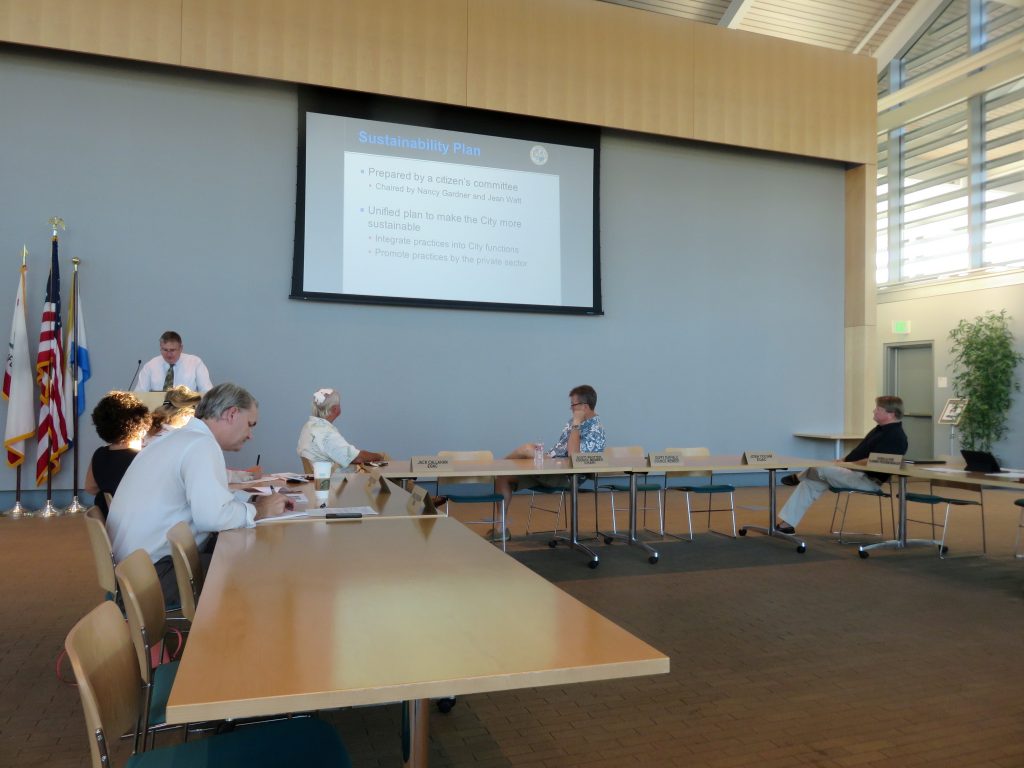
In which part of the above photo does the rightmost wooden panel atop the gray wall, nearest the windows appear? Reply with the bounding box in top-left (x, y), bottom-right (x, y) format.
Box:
top-left (693, 25), bottom-right (877, 163)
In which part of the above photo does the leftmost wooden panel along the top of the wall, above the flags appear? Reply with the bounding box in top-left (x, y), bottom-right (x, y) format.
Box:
top-left (0, 0), bottom-right (181, 65)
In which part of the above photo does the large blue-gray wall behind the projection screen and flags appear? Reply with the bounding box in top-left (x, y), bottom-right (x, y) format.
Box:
top-left (0, 47), bottom-right (844, 505)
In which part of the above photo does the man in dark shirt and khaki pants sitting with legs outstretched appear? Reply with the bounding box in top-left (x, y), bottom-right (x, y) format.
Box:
top-left (776, 395), bottom-right (907, 534)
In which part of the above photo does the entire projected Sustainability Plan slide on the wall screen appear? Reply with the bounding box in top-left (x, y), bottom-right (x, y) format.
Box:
top-left (293, 111), bottom-right (599, 313)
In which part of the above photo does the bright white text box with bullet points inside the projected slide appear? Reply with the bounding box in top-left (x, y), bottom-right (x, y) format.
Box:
top-left (341, 153), bottom-right (562, 304)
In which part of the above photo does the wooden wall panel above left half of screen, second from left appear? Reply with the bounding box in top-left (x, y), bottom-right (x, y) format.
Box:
top-left (182, 0), bottom-right (466, 104)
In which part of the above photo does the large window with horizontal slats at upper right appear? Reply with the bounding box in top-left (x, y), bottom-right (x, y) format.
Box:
top-left (876, 0), bottom-right (1024, 285)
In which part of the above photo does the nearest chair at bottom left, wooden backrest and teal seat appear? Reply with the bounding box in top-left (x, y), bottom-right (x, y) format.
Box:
top-left (65, 601), bottom-right (351, 768)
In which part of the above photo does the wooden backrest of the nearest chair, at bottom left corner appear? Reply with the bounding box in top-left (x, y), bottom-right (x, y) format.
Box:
top-left (65, 602), bottom-right (145, 768)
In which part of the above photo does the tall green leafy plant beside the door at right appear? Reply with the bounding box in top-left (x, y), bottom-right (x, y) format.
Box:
top-left (949, 309), bottom-right (1024, 451)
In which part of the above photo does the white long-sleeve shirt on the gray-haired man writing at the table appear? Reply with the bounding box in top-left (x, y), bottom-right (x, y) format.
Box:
top-left (106, 419), bottom-right (256, 562)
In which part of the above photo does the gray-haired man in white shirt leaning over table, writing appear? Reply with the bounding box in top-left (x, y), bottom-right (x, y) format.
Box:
top-left (106, 383), bottom-right (292, 605)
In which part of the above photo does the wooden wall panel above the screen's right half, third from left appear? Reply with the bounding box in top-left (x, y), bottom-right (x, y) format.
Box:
top-left (467, 0), bottom-right (694, 136)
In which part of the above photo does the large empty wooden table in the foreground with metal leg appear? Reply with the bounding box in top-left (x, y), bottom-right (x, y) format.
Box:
top-left (167, 507), bottom-right (669, 766)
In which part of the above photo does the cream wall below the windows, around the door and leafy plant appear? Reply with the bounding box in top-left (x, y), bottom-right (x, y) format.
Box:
top-left (878, 276), bottom-right (1024, 467)
